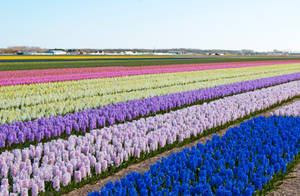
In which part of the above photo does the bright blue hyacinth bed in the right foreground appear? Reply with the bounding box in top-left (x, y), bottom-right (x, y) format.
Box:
top-left (88, 116), bottom-right (300, 196)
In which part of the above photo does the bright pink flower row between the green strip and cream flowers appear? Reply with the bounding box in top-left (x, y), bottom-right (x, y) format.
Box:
top-left (0, 60), bottom-right (300, 86)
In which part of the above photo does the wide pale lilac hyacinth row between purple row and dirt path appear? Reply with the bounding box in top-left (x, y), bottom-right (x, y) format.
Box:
top-left (0, 82), bottom-right (299, 195)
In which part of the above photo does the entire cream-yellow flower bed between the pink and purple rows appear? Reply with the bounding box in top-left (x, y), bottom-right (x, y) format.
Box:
top-left (0, 65), bottom-right (300, 124)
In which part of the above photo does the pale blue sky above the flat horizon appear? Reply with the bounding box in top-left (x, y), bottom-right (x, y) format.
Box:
top-left (0, 0), bottom-right (300, 51)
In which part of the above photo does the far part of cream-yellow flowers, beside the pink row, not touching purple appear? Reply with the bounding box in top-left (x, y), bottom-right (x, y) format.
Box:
top-left (0, 64), bottom-right (300, 109)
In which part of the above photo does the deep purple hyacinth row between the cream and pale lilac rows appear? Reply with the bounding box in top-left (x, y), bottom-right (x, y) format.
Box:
top-left (0, 73), bottom-right (300, 148)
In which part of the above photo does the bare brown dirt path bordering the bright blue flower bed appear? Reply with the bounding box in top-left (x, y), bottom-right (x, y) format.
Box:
top-left (65, 99), bottom-right (300, 196)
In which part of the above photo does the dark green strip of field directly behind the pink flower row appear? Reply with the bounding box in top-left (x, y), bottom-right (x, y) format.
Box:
top-left (0, 56), bottom-right (300, 71)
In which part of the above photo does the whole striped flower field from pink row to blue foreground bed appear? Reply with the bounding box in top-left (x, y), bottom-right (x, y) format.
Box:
top-left (0, 60), bottom-right (300, 196)
